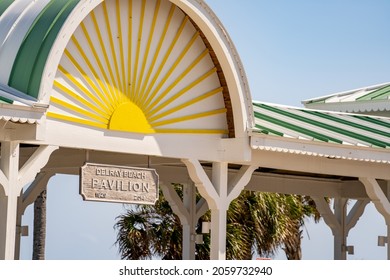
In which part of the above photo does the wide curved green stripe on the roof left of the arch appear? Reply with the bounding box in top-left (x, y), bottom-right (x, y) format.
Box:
top-left (8, 0), bottom-right (80, 98)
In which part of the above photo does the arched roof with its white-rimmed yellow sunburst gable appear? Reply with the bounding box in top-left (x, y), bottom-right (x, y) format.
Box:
top-left (0, 0), bottom-right (253, 137)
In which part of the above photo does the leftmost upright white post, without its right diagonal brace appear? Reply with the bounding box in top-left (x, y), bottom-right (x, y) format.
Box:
top-left (0, 142), bottom-right (20, 260)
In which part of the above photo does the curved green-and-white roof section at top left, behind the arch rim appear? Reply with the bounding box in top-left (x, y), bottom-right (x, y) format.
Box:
top-left (0, 0), bottom-right (80, 101)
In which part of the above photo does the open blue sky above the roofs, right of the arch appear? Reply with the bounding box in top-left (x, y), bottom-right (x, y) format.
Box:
top-left (206, 0), bottom-right (390, 105)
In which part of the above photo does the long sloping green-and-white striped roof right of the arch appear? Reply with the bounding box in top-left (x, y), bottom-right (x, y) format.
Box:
top-left (253, 102), bottom-right (390, 149)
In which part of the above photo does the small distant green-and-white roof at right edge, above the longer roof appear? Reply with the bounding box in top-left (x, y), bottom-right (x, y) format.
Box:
top-left (302, 83), bottom-right (390, 117)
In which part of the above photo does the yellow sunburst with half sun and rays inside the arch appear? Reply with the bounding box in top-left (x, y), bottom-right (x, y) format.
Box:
top-left (48, 0), bottom-right (227, 134)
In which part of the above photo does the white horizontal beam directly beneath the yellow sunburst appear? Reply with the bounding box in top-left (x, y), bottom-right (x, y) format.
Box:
top-left (42, 119), bottom-right (249, 162)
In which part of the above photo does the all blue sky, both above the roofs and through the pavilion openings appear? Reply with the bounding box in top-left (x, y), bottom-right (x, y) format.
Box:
top-left (22, 0), bottom-right (390, 259)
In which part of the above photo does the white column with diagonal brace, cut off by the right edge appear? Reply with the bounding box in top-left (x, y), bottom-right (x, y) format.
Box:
top-left (359, 178), bottom-right (390, 260)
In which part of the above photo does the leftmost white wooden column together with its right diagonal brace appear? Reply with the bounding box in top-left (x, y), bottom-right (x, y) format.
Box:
top-left (0, 142), bottom-right (58, 260)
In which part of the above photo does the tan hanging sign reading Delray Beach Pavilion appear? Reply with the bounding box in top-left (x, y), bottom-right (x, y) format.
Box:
top-left (80, 163), bottom-right (158, 204)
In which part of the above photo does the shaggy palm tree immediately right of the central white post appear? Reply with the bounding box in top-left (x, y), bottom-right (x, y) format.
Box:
top-left (226, 191), bottom-right (288, 259)
